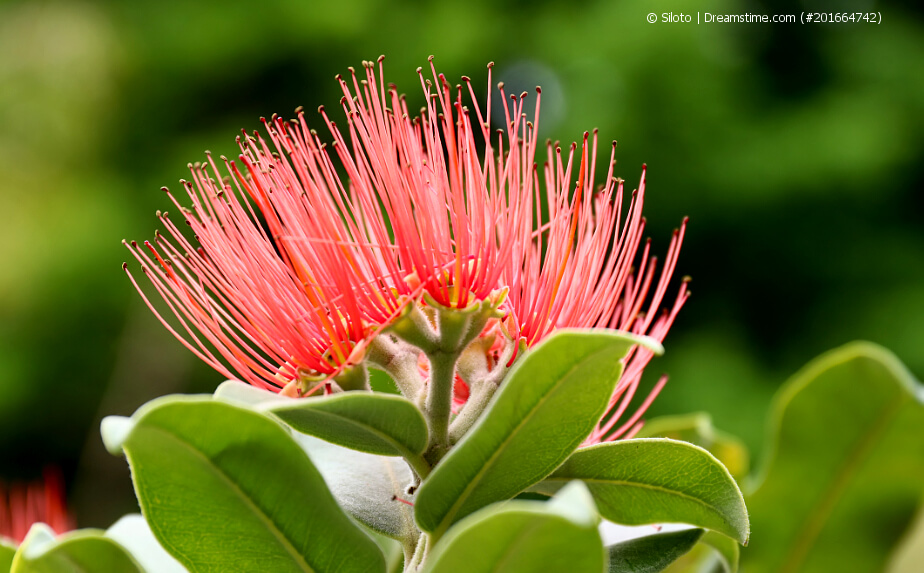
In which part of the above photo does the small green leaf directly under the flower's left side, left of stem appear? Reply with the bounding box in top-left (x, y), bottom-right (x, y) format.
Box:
top-left (258, 392), bottom-right (428, 457)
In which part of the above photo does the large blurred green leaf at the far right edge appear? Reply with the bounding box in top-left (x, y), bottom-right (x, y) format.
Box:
top-left (741, 343), bottom-right (924, 573)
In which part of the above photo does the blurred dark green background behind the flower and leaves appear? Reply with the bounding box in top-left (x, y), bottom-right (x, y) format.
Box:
top-left (0, 0), bottom-right (924, 526)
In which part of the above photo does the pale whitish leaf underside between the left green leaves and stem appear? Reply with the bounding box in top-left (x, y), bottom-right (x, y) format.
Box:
top-left (294, 434), bottom-right (420, 542)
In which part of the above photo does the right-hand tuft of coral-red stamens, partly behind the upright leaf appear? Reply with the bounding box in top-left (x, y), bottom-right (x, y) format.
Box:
top-left (494, 139), bottom-right (689, 444)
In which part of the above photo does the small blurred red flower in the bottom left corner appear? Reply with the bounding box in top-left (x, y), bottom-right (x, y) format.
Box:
top-left (0, 469), bottom-right (74, 544)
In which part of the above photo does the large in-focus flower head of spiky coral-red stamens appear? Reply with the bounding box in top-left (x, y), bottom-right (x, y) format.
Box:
top-left (124, 58), bottom-right (688, 428)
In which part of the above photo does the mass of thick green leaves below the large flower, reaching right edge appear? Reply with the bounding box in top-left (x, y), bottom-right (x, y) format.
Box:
top-left (88, 331), bottom-right (924, 573)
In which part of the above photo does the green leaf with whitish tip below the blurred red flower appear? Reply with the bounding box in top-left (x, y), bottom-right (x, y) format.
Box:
top-left (10, 523), bottom-right (143, 573)
